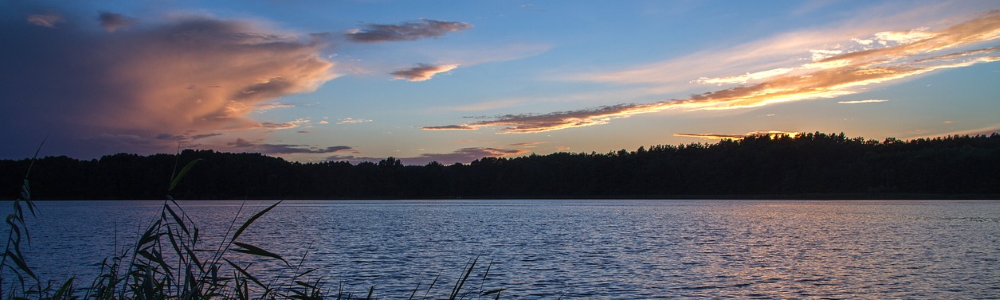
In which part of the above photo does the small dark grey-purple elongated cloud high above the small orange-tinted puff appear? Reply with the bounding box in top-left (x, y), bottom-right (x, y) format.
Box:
top-left (344, 19), bottom-right (472, 43)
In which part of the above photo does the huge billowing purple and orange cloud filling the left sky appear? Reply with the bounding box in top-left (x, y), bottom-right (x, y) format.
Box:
top-left (0, 9), bottom-right (336, 157)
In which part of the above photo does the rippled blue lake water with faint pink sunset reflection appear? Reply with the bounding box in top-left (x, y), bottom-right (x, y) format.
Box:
top-left (9, 200), bottom-right (1000, 299)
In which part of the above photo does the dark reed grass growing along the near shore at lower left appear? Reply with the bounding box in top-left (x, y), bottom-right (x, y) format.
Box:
top-left (0, 149), bottom-right (505, 300)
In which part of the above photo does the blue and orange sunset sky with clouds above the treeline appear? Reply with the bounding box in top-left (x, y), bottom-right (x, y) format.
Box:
top-left (0, 0), bottom-right (1000, 165)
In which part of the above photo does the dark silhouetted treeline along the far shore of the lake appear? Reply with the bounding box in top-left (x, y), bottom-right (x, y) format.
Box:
top-left (0, 132), bottom-right (1000, 200)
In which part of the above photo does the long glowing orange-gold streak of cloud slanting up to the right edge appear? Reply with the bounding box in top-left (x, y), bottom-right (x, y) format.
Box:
top-left (423, 11), bottom-right (1000, 133)
